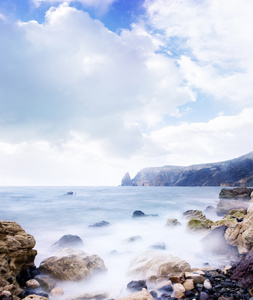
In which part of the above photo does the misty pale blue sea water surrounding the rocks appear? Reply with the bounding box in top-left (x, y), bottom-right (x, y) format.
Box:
top-left (0, 186), bottom-right (222, 298)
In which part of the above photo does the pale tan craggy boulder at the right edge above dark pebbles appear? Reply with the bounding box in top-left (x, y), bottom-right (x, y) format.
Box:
top-left (225, 203), bottom-right (253, 254)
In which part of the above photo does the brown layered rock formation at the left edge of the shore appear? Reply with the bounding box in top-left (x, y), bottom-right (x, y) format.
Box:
top-left (0, 221), bottom-right (37, 295)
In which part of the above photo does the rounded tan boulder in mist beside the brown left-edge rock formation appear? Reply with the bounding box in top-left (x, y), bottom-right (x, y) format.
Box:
top-left (39, 248), bottom-right (107, 281)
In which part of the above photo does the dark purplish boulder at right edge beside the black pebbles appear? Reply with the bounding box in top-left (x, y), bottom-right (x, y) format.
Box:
top-left (231, 252), bottom-right (253, 287)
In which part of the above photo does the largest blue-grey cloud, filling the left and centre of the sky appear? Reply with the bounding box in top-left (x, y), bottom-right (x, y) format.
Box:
top-left (0, 4), bottom-right (194, 155)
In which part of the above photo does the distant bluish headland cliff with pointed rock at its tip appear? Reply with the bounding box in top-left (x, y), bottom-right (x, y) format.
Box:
top-left (121, 152), bottom-right (253, 186)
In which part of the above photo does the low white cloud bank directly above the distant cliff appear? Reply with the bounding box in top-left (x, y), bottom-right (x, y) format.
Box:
top-left (142, 108), bottom-right (253, 166)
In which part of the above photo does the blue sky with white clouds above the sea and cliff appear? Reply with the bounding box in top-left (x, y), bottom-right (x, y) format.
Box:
top-left (0, 0), bottom-right (253, 186)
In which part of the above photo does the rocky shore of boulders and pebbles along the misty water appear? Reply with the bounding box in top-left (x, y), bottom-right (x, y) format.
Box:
top-left (0, 188), bottom-right (253, 300)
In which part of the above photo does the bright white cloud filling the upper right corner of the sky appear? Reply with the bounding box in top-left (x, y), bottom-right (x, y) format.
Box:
top-left (145, 0), bottom-right (253, 108)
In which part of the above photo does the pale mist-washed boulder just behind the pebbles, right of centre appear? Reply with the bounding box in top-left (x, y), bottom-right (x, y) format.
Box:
top-left (128, 251), bottom-right (191, 280)
